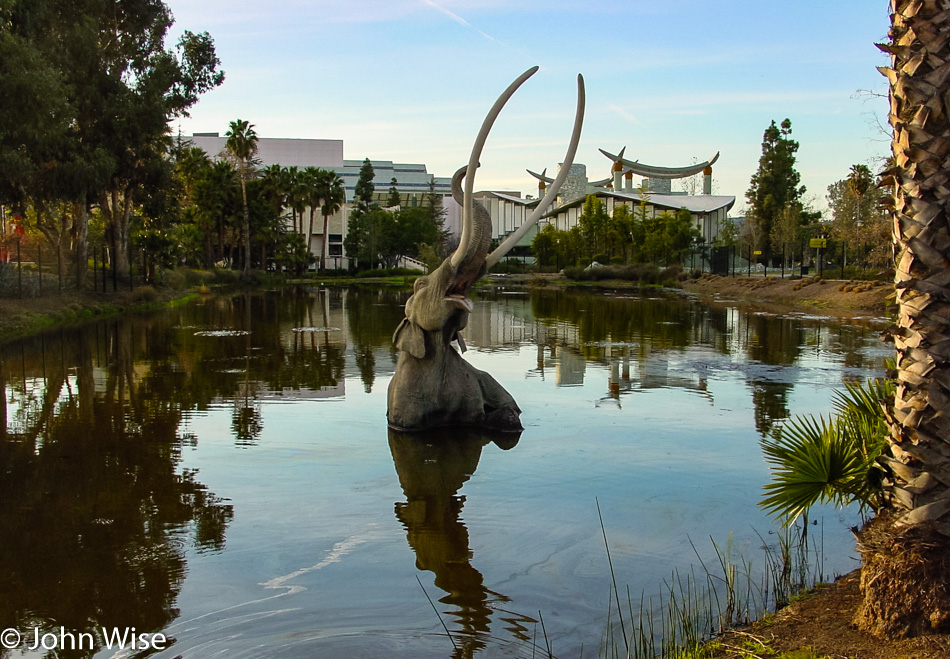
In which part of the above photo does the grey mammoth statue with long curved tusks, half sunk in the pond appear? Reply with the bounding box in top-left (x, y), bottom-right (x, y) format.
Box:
top-left (386, 67), bottom-right (585, 431)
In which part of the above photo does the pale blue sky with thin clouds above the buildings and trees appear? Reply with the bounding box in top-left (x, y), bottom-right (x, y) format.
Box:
top-left (166, 0), bottom-right (890, 214)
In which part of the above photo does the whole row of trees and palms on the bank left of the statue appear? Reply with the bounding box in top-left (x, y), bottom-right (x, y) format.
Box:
top-left (0, 0), bottom-right (458, 288)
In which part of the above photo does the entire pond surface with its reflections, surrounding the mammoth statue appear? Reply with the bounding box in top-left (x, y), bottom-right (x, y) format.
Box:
top-left (0, 288), bottom-right (889, 658)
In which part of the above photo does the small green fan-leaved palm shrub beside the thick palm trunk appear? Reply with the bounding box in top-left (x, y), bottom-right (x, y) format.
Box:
top-left (759, 378), bottom-right (894, 526)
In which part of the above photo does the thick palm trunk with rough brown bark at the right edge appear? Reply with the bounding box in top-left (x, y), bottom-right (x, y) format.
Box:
top-left (856, 0), bottom-right (950, 635)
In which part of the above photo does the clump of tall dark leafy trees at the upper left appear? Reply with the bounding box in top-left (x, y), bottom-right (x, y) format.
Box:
top-left (0, 0), bottom-right (224, 286)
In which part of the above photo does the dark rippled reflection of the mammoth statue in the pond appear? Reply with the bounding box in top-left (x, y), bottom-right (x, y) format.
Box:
top-left (389, 427), bottom-right (537, 657)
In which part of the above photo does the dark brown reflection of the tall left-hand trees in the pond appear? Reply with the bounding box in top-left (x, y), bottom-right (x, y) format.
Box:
top-left (0, 319), bottom-right (233, 656)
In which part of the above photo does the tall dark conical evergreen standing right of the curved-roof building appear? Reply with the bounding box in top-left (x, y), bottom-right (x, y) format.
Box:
top-left (746, 119), bottom-right (805, 249)
